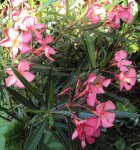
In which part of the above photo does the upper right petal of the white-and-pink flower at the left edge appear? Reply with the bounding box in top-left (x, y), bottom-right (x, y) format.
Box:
top-left (20, 32), bottom-right (32, 43)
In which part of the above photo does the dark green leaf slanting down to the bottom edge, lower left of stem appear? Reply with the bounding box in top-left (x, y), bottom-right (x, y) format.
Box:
top-left (23, 120), bottom-right (46, 150)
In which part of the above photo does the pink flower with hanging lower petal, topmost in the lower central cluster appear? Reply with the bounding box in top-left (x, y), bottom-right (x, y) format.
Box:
top-left (85, 73), bottom-right (111, 106)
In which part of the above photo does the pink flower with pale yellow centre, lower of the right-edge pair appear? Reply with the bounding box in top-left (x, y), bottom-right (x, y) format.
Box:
top-left (119, 68), bottom-right (137, 91)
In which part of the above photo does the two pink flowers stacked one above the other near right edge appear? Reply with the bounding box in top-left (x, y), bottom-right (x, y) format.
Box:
top-left (115, 50), bottom-right (137, 91)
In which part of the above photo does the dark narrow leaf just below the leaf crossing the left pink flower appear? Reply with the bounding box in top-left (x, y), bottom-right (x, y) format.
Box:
top-left (6, 88), bottom-right (37, 109)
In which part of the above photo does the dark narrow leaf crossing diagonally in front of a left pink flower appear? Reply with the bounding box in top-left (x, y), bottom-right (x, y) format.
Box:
top-left (12, 68), bottom-right (45, 105)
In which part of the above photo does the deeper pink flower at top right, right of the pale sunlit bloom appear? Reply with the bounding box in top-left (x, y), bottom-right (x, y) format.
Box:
top-left (108, 6), bottom-right (134, 28)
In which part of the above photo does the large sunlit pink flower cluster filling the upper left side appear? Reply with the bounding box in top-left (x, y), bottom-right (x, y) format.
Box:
top-left (0, 0), bottom-right (56, 88)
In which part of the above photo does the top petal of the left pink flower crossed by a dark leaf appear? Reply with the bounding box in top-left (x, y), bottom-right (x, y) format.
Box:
top-left (18, 60), bottom-right (30, 72)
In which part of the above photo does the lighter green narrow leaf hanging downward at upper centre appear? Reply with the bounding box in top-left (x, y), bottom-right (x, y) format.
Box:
top-left (83, 31), bottom-right (96, 68)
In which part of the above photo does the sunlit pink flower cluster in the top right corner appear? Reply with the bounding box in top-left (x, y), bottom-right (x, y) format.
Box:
top-left (87, 0), bottom-right (135, 28)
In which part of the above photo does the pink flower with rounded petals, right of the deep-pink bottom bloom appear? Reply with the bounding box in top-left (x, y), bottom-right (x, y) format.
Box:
top-left (95, 100), bottom-right (116, 128)
